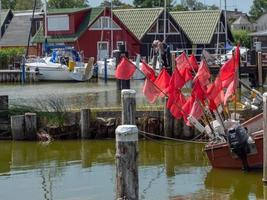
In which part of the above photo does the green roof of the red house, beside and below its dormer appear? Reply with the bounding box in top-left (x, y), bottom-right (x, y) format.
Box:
top-left (32, 8), bottom-right (103, 43)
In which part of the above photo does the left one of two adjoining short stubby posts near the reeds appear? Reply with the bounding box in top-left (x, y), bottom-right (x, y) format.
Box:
top-left (11, 115), bottom-right (25, 140)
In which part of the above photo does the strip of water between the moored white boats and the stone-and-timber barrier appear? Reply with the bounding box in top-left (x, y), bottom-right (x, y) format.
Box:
top-left (0, 80), bottom-right (152, 109)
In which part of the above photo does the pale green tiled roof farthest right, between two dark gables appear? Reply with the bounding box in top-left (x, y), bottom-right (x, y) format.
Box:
top-left (170, 10), bottom-right (221, 44)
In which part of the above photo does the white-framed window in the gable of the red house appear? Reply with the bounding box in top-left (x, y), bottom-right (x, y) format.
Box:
top-left (90, 17), bottom-right (121, 30)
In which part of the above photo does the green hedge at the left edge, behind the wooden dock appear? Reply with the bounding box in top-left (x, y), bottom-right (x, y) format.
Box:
top-left (0, 48), bottom-right (25, 69)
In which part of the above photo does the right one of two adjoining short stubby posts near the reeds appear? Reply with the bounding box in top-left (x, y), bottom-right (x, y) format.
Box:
top-left (24, 113), bottom-right (37, 140)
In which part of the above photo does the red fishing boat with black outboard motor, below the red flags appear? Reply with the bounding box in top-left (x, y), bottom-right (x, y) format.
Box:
top-left (204, 113), bottom-right (263, 169)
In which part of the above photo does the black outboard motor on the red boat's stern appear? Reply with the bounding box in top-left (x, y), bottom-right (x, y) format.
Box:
top-left (228, 126), bottom-right (249, 171)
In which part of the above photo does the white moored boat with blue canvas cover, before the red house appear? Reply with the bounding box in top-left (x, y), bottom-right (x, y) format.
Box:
top-left (25, 48), bottom-right (94, 81)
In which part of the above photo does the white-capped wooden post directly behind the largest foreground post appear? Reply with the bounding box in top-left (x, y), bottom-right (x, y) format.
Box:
top-left (121, 90), bottom-right (136, 124)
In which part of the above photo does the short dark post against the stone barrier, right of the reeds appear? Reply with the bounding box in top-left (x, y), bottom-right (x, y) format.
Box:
top-left (80, 109), bottom-right (92, 139)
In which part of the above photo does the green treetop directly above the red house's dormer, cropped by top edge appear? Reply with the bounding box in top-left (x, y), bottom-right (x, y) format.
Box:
top-left (48, 0), bottom-right (88, 8)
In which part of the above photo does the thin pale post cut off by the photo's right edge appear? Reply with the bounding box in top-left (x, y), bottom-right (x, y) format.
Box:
top-left (262, 92), bottom-right (267, 184)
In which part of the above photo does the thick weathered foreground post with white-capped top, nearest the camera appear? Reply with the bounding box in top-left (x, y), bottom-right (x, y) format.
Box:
top-left (116, 125), bottom-right (139, 200)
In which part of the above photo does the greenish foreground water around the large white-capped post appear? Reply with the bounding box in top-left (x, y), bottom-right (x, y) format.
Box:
top-left (0, 140), bottom-right (264, 200)
